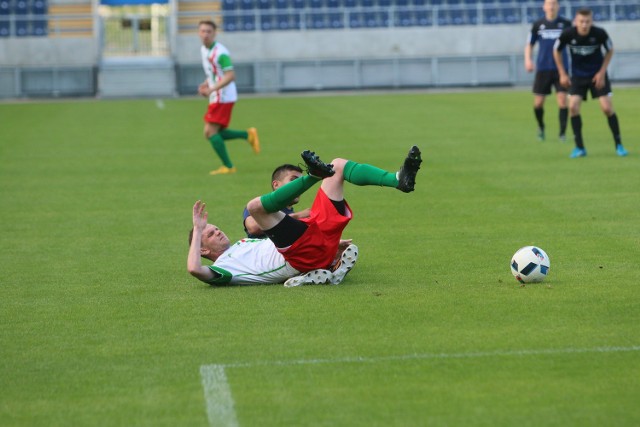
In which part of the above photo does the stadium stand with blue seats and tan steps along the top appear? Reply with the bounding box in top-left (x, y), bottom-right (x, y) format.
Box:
top-left (0, 0), bottom-right (640, 38)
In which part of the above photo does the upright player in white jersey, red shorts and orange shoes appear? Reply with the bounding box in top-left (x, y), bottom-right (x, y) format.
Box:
top-left (198, 21), bottom-right (260, 175)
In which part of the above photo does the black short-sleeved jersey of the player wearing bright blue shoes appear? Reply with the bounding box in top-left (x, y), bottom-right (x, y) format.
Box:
top-left (555, 27), bottom-right (613, 77)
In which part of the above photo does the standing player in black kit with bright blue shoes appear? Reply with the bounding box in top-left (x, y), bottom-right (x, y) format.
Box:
top-left (553, 8), bottom-right (627, 158)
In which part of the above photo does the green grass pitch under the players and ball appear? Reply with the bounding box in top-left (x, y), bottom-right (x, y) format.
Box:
top-left (0, 87), bottom-right (640, 427)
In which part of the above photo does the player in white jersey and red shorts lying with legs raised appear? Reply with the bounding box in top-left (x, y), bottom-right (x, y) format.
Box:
top-left (187, 146), bottom-right (422, 286)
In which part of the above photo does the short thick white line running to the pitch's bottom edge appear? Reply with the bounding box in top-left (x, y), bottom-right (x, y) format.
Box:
top-left (200, 365), bottom-right (238, 427)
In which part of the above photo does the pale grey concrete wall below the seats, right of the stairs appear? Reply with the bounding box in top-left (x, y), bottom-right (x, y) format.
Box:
top-left (174, 22), bottom-right (640, 63)
